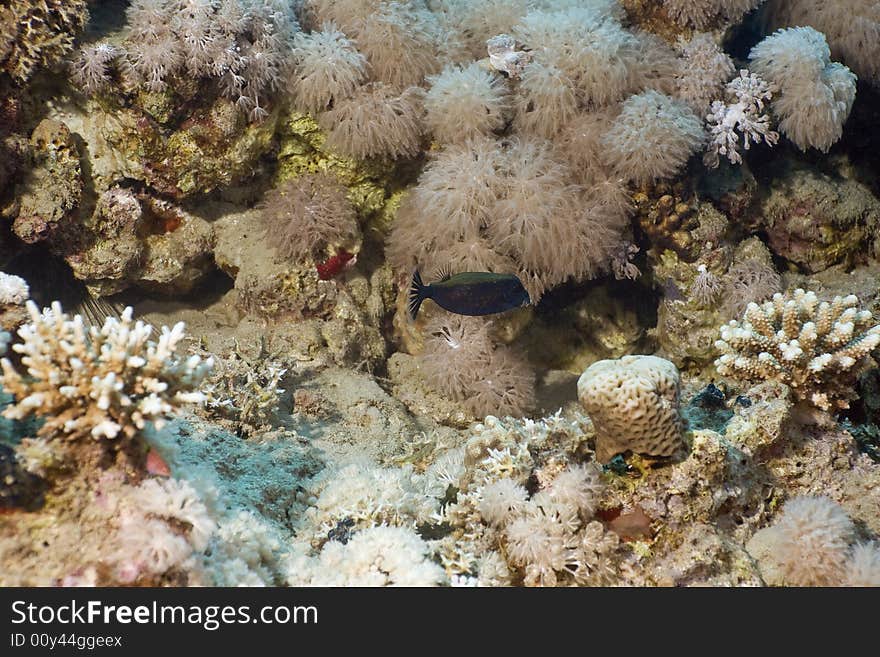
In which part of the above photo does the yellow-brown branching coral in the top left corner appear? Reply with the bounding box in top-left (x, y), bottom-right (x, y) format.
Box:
top-left (0, 0), bottom-right (89, 84)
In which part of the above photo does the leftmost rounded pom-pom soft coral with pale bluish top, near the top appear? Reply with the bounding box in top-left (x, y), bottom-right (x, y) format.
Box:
top-left (291, 23), bottom-right (367, 113)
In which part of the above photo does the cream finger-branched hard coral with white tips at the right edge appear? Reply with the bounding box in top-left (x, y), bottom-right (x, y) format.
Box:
top-left (715, 289), bottom-right (880, 411)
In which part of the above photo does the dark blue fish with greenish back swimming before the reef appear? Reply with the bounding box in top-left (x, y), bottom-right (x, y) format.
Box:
top-left (409, 270), bottom-right (531, 319)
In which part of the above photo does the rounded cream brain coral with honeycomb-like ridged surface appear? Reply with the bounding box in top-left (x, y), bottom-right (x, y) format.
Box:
top-left (578, 356), bottom-right (682, 462)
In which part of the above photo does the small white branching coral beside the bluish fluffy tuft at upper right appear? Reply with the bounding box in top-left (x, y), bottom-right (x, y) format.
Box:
top-left (706, 70), bottom-right (779, 166)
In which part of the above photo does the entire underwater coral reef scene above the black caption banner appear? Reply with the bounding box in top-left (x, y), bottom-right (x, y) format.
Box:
top-left (0, 0), bottom-right (880, 587)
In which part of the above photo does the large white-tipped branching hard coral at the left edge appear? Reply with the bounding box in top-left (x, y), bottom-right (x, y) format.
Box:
top-left (0, 301), bottom-right (213, 439)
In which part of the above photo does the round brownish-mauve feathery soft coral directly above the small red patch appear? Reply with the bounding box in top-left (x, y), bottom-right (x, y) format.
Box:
top-left (260, 173), bottom-right (360, 261)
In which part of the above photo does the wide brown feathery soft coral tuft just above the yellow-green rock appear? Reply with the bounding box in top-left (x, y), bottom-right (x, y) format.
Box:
top-left (318, 82), bottom-right (424, 159)
